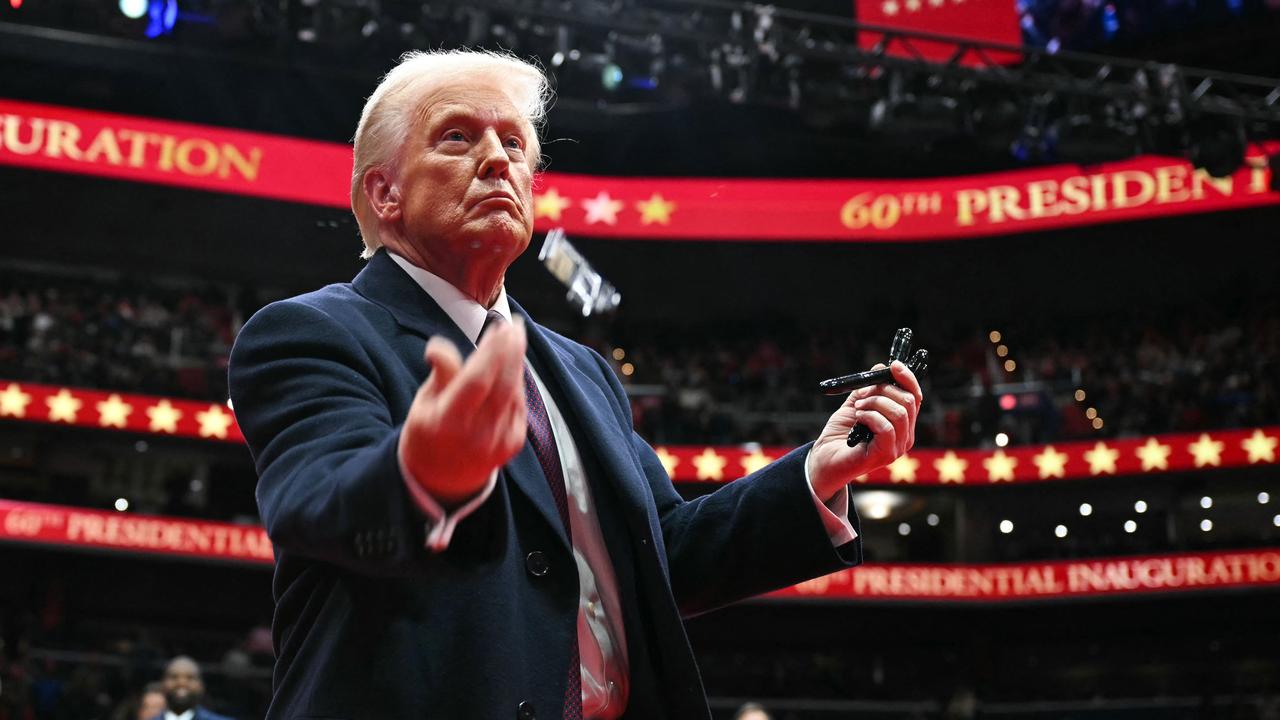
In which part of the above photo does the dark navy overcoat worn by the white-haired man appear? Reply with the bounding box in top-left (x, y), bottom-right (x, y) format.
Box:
top-left (230, 251), bottom-right (861, 720)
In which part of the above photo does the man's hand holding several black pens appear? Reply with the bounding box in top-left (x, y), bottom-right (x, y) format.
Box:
top-left (808, 360), bottom-right (924, 500)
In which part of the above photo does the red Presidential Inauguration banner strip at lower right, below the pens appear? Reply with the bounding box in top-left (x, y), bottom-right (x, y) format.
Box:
top-left (769, 548), bottom-right (1280, 602)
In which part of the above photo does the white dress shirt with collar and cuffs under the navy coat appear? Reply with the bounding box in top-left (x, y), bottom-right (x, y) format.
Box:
top-left (389, 252), bottom-right (858, 720)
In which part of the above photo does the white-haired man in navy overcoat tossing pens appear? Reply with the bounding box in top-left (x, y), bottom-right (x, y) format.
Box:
top-left (230, 51), bottom-right (922, 720)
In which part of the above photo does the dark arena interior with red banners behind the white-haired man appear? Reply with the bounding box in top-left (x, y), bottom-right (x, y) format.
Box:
top-left (0, 0), bottom-right (1280, 720)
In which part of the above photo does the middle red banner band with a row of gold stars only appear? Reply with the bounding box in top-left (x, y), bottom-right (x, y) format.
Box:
top-left (0, 380), bottom-right (1280, 486)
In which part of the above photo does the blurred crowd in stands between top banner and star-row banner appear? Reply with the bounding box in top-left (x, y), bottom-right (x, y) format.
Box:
top-left (0, 260), bottom-right (1280, 447)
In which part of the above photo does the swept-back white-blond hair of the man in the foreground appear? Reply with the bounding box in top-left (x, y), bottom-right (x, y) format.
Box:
top-left (351, 50), bottom-right (552, 259)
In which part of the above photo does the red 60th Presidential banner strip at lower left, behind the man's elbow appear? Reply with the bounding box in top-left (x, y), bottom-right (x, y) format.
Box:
top-left (0, 500), bottom-right (274, 565)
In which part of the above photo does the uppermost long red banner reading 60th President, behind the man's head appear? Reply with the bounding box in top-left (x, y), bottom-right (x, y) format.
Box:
top-left (0, 98), bottom-right (1280, 242)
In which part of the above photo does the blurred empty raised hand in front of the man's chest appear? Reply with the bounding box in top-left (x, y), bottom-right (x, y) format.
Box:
top-left (399, 318), bottom-right (527, 507)
